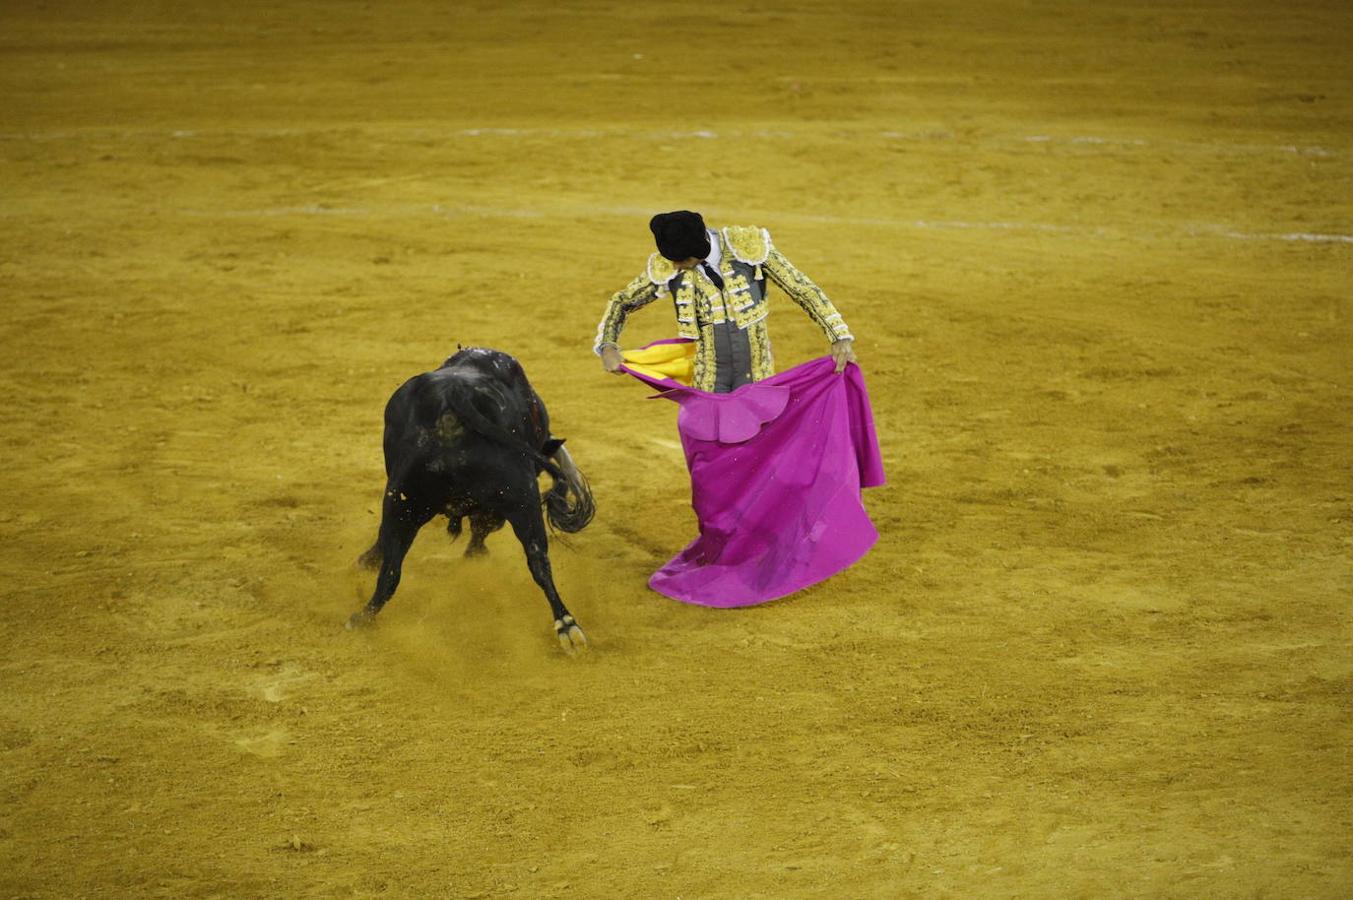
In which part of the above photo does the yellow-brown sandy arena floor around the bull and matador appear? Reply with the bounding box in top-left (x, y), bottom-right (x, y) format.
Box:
top-left (0, 0), bottom-right (1353, 897)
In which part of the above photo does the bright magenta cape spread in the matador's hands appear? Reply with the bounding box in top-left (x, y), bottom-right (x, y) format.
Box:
top-left (624, 346), bottom-right (884, 608)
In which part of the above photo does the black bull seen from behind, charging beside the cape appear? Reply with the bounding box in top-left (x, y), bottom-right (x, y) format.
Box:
top-left (348, 348), bottom-right (595, 652)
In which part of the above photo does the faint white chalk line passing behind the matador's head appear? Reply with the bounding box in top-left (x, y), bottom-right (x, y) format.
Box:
top-left (180, 203), bottom-right (1353, 244)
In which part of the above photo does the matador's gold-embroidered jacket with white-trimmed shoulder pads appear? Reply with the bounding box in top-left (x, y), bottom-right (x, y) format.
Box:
top-left (593, 226), bottom-right (851, 391)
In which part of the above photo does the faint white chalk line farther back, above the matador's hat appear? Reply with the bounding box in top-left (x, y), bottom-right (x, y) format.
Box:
top-left (0, 125), bottom-right (1341, 158)
